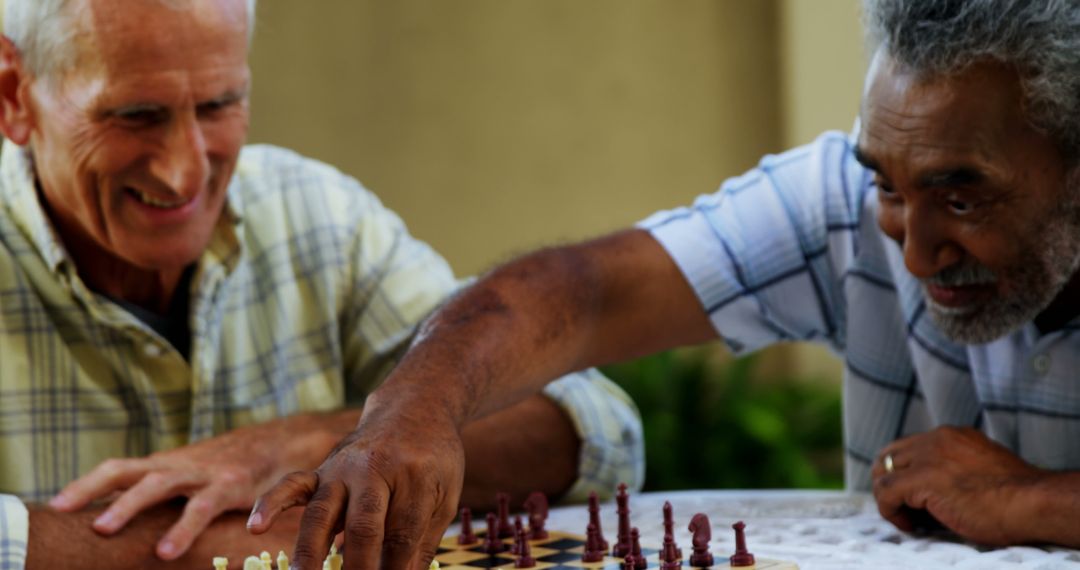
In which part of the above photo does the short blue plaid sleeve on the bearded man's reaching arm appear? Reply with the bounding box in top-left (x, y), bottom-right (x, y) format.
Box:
top-left (638, 133), bottom-right (870, 353)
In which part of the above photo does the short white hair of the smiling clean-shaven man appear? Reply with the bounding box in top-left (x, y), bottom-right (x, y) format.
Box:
top-left (0, 0), bottom-right (256, 77)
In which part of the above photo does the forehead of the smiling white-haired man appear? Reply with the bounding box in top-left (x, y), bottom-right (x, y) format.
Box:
top-left (72, 0), bottom-right (248, 72)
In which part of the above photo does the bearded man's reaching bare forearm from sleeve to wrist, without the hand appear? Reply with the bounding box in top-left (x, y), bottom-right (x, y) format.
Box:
top-left (368, 231), bottom-right (715, 425)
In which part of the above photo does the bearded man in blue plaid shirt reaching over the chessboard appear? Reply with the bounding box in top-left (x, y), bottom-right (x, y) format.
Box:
top-left (253, 0), bottom-right (1080, 569)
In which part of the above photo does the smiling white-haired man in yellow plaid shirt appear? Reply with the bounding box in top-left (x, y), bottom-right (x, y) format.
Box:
top-left (0, 0), bottom-right (642, 570)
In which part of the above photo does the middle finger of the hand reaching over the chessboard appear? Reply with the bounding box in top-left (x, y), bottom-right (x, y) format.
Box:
top-left (345, 476), bottom-right (390, 570)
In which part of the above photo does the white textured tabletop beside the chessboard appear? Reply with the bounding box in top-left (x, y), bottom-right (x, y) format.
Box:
top-left (527, 491), bottom-right (1080, 570)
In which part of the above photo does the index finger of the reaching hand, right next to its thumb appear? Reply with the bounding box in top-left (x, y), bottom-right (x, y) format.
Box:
top-left (292, 481), bottom-right (347, 570)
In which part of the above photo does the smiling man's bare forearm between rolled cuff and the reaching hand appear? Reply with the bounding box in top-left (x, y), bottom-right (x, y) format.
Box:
top-left (461, 395), bottom-right (581, 510)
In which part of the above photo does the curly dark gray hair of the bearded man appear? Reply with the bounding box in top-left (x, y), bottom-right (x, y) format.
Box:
top-left (863, 0), bottom-right (1080, 160)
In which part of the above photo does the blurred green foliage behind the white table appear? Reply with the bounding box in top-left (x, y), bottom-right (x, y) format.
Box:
top-left (603, 350), bottom-right (843, 490)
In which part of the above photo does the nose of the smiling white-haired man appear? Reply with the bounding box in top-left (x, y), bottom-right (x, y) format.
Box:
top-left (150, 114), bottom-right (210, 199)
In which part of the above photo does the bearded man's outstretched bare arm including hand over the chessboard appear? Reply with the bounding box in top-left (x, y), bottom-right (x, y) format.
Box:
top-left (249, 230), bottom-right (716, 569)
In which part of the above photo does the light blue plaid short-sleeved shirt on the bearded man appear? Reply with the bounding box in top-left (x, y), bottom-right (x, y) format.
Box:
top-left (640, 133), bottom-right (1080, 489)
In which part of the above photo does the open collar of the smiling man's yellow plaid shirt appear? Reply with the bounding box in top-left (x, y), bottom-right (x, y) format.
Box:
top-left (0, 140), bottom-right (243, 275)
